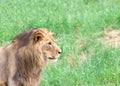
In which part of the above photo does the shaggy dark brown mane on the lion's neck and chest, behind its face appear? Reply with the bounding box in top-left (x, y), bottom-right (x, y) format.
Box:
top-left (14, 30), bottom-right (44, 83)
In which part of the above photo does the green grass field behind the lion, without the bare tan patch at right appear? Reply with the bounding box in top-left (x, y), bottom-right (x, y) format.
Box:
top-left (0, 0), bottom-right (120, 86)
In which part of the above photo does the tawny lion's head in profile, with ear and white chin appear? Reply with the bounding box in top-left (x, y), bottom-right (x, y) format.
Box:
top-left (33, 29), bottom-right (61, 60)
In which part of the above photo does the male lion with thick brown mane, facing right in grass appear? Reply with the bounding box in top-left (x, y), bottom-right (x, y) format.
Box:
top-left (0, 28), bottom-right (61, 86)
